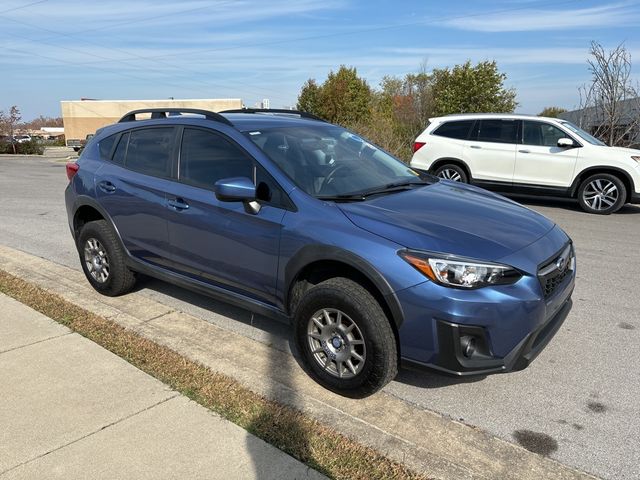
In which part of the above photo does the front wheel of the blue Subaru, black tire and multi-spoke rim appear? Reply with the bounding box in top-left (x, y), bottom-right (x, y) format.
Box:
top-left (294, 278), bottom-right (398, 398)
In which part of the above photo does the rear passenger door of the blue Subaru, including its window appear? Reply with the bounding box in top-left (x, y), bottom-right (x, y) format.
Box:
top-left (95, 126), bottom-right (176, 265)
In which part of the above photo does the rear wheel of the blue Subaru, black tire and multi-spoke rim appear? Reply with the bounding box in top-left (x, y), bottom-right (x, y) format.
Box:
top-left (77, 220), bottom-right (136, 297)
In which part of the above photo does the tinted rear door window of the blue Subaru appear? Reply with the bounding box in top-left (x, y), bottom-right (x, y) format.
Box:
top-left (124, 127), bottom-right (175, 177)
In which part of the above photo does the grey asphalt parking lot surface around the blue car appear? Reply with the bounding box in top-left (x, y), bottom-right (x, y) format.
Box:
top-left (0, 156), bottom-right (640, 479)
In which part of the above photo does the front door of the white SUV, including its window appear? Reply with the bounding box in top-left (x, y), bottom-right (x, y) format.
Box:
top-left (513, 120), bottom-right (579, 187)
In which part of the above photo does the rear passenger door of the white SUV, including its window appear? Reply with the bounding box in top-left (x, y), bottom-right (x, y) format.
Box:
top-left (464, 118), bottom-right (520, 184)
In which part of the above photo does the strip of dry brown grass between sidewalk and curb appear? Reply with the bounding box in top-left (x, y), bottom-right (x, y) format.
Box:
top-left (0, 270), bottom-right (425, 479)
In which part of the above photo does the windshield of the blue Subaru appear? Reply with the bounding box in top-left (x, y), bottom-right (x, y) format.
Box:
top-left (246, 125), bottom-right (422, 197)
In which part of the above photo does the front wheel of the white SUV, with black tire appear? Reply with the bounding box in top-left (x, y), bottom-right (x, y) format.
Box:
top-left (578, 173), bottom-right (627, 215)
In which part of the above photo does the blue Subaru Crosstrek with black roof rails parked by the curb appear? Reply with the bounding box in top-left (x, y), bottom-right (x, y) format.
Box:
top-left (65, 109), bottom-right (575, 397)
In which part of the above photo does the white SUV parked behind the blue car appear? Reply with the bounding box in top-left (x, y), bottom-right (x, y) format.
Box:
top-left (411, 114), bottom-right (640, 214)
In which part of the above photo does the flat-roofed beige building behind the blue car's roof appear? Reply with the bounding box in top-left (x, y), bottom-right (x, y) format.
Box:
top-left (60, 98), bottom-right (242, 145)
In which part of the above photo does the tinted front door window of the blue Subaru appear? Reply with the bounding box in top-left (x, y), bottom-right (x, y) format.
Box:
top-left (180, 128), bottom-right (253, 190)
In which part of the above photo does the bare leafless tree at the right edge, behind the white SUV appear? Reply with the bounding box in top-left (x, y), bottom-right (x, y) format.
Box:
top-left (579, 42), bottom-right (640, 146)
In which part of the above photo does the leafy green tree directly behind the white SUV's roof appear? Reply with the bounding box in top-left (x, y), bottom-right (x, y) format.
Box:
top-left (431, 61), bottom-right (518, 115)
